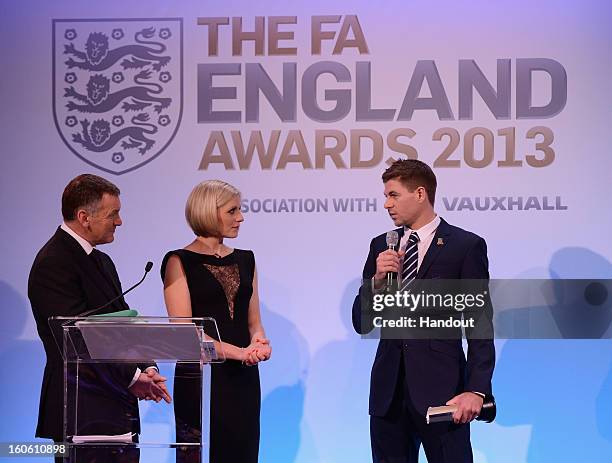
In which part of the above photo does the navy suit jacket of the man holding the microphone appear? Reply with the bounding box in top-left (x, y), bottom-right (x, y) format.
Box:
top-left (353, 220), bottom-right (495, 416)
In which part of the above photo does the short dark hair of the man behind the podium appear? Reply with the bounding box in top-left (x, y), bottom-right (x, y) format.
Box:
top-left (62, 174), bottom-right (121, 221)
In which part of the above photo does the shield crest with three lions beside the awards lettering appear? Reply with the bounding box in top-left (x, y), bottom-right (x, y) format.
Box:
top-left (53, 18), bottom-right (183, 175)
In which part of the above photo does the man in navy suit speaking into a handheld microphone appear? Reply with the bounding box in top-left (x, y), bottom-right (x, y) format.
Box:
top-left (353, 160), bottom-right (495, 463)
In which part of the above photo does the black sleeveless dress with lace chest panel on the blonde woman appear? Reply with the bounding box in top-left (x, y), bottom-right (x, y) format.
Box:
top-left (161, 249), bottom-right (261, 463)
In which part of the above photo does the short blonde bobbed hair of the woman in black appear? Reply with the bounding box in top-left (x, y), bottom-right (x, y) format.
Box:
top-left (185, 180), bottom-right (240, 236)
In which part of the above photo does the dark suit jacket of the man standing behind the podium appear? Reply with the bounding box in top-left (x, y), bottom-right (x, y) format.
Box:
top-left (28, 228), bottom-right (139, 440)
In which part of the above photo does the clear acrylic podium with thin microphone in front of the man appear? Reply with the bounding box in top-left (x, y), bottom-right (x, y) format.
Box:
top-left (49, 316), bottom-right (225, 462)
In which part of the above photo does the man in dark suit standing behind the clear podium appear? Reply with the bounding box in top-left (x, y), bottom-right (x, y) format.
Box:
top-left (28, 174), bottom-right (170, 461)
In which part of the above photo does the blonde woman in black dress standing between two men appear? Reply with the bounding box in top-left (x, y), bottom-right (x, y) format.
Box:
top-left (161, 180), bottom-right (271, 463)
